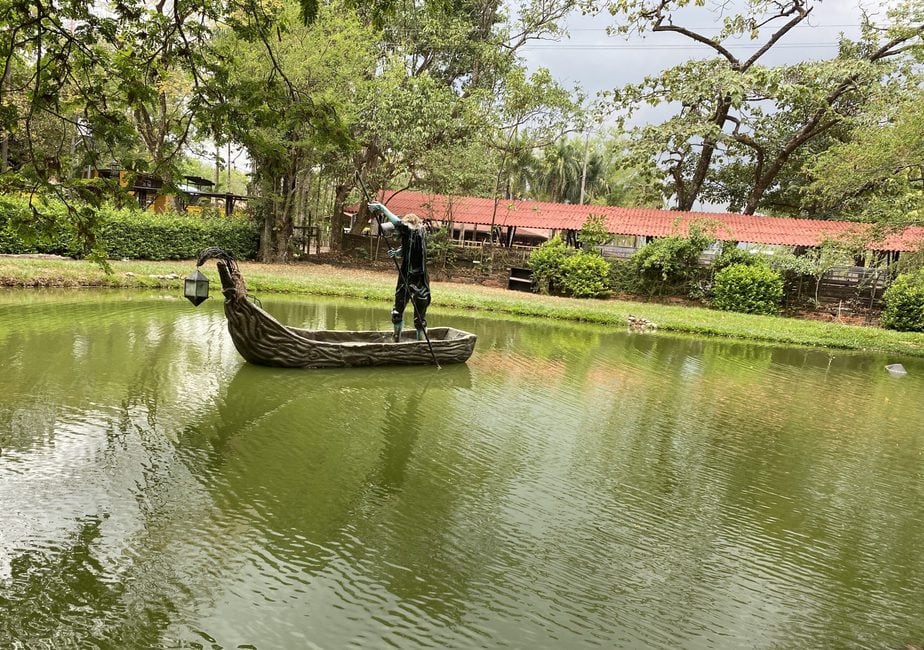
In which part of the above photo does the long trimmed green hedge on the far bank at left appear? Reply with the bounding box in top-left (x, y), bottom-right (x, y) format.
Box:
top-left (0, 196), bottom-right (259, 260)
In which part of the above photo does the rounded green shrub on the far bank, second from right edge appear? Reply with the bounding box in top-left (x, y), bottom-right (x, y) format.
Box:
top-left (713, 264), bottom-right (783, 314)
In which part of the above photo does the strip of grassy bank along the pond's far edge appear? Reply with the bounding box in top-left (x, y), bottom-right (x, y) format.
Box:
top-left (0, 257), bottom-right (924, 356)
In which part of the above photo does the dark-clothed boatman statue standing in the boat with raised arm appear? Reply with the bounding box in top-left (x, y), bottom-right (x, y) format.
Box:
top-left (369, 201), bottom-right (430, 342)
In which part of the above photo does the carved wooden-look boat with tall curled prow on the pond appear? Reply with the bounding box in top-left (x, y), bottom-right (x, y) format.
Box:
top-left (197, 248), bottom-right (476, 368)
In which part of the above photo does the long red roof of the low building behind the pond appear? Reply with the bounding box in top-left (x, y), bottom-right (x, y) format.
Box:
top-left (379, 190), bottom-right (924, 251)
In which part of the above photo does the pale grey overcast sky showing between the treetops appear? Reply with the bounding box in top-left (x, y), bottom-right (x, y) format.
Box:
top-left (521, 0), bottom-right (884, 122)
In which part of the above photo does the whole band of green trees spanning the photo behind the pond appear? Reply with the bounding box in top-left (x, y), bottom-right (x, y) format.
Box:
top-left (0, 0), bottom-right (924, 260)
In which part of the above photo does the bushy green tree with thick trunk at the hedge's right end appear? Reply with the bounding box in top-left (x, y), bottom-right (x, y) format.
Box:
top-left (206, 2), bottom-right (376, 261)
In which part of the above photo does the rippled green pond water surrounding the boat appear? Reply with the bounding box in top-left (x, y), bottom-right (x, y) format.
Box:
top-left (0, 291), bottom-right (924, 648)
